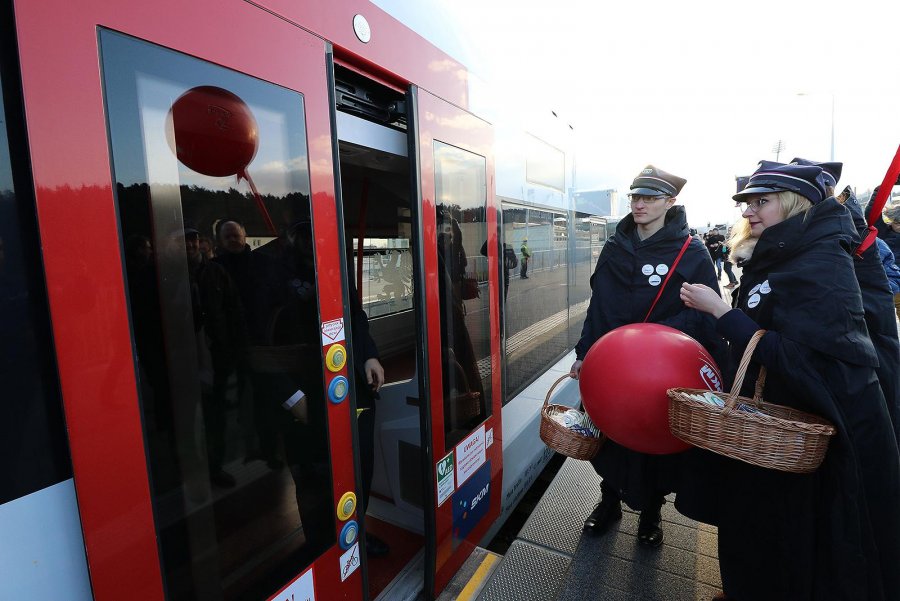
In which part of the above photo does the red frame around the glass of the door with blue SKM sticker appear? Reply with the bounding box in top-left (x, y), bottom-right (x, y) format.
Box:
top-left (418, 91), bottom-right (503, 594)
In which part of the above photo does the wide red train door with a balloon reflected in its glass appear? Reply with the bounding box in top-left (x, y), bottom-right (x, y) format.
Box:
top-left (16, 0), bottom-right (363, 601)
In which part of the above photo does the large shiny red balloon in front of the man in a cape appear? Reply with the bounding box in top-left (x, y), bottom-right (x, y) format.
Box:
top-left (579, 323), bottom-right (722, 455)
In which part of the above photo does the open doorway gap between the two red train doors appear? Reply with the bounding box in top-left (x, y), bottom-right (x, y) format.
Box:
top-left (334, 64), bottom-right (427, 599)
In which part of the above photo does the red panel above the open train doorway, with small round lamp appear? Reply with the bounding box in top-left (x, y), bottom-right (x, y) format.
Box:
top-left (250, 0), bottom-right (468, 108)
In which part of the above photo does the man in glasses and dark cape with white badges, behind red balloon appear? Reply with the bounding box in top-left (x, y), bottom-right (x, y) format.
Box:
top-left (570, 165), bottom-right (721, 547)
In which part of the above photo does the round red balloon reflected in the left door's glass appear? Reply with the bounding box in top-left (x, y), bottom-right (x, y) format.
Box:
top-left (166, 86), bottom-right (259, 177)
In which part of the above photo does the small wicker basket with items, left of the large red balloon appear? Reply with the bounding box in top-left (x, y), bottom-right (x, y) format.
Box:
top-left (540, 374), bottom-right (606, 460)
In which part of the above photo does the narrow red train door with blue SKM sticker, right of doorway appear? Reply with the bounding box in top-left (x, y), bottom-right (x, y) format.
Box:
top-left (412, 89), bottom-right (503, 595)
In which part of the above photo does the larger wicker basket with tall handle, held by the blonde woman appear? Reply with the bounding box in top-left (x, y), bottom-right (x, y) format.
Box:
top-left (668, 330), bottom-right (835, 474)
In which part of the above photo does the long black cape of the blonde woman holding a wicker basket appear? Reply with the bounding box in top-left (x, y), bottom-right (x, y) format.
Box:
top-left (676, 198), bottom-right (900, 601)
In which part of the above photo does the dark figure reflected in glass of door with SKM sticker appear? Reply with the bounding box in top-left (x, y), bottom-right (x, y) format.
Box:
top-left (437, 210), bottom-right (484, 432)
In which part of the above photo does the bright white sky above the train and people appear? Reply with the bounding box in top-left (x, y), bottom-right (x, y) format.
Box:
top-left (377, 0), bottom-right (900, 225)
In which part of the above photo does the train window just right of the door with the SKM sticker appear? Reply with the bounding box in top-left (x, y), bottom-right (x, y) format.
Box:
top-left (502, 203), bottom-right (571, 399)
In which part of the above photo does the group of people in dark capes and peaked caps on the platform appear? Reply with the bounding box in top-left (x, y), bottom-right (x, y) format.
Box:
top-left (570, 158), bottom-right (900, 601)
